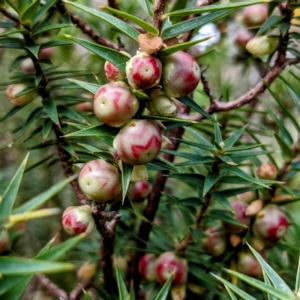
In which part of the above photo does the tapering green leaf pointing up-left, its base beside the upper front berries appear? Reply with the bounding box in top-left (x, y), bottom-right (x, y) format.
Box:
top-left (67, 35), bottom-right (130, 72)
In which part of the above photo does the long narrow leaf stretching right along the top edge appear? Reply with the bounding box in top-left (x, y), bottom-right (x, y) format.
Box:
top-left (163, 0), bottom-right (265, 18)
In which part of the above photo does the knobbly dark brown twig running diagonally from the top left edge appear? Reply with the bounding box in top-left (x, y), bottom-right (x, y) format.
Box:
top-left (56, 2), bottom-right (123, 50)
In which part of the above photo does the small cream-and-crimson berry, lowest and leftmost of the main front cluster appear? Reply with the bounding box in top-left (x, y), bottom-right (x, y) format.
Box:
top-left (62, 205), bottom-right (95, 235)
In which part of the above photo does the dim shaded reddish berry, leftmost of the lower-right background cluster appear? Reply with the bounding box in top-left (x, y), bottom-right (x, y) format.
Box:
top-left (203, 226), bottom-right (227, 256)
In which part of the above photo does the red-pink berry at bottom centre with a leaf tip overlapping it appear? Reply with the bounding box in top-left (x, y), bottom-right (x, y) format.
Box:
top-left (155, 252), bottom-right (188, 285)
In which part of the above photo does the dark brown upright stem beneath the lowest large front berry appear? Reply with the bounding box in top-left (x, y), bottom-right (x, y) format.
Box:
top-left (92, 204), bottom-right (121, 293)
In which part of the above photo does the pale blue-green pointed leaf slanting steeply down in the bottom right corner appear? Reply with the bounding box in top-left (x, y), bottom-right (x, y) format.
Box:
top-left (248, 245), bottom-right (295, 299)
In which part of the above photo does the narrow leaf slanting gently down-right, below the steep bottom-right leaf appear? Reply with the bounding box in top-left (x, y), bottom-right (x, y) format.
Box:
top-left (226, 270), bottom-right (294, 300)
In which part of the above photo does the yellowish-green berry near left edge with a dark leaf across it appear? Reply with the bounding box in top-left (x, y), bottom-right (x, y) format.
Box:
top-left (5, 83), bottom-right (36, 106)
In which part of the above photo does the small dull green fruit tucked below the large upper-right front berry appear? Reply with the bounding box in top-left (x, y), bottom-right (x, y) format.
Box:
top-left (146, 95), bottom-right (177, 117)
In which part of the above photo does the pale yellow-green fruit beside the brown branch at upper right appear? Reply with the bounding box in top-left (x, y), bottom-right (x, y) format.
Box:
top-left (246, 36), bottom-right (279, 56)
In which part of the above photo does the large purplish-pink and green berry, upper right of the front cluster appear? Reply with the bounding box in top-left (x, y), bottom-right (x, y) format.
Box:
top-left (162, 51), bottom-right (200, 97)
